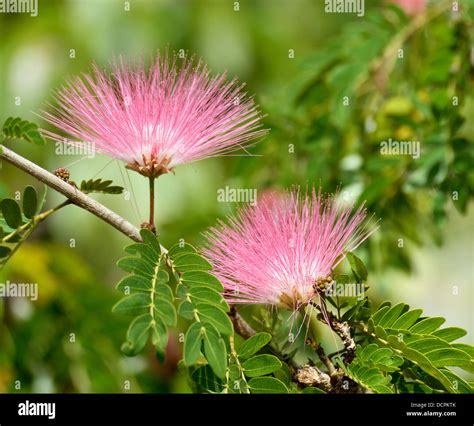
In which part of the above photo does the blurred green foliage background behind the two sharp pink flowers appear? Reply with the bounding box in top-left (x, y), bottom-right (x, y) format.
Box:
top-left (0, 0), bottom-right (474, 392)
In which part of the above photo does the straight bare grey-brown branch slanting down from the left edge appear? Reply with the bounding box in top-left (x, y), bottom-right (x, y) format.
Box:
top-left (0, 145), bottom-right (141, 241)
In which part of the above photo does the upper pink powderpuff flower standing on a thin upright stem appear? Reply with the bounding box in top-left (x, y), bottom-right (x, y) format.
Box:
top-left (43, 53), bottom-right (266, 177)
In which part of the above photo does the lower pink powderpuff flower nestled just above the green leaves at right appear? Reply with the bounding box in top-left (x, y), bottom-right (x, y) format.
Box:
top-left (204, 189), bottom-right (376, 310)
